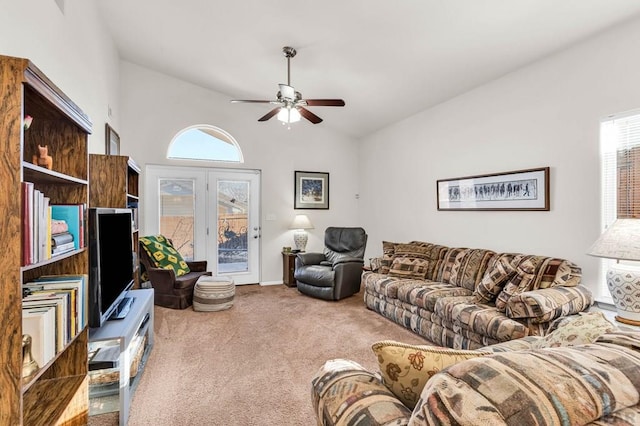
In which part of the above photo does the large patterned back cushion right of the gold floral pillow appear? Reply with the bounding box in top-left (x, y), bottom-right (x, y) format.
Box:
top-left (409, 343), bottom-right (640, 426)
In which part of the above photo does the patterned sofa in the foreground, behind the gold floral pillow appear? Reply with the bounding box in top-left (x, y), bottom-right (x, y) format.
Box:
top-left (311, 331), bottom-right (640, 426)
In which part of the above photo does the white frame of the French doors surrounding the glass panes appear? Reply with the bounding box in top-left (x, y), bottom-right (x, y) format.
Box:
top-left (143, 164), bottom-right (262, 284)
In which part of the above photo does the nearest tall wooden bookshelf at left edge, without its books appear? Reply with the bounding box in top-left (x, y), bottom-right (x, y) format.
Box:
top-left (0, 56), bottom-right (91, 425)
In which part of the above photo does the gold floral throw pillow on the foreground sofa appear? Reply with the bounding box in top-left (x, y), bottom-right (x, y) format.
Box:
top-left (371, 340), bottom-right (490, 409)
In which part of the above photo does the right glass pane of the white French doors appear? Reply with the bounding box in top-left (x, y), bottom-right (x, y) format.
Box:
top-left (217, 180), bottom-right (250, 273)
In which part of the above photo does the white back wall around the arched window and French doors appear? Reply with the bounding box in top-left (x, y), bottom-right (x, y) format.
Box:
top-left (117, 62), bottom-right (358, 283)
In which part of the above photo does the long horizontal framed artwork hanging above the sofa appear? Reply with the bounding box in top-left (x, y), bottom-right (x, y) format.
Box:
top-left (436, 167), bottom-right (550, 211)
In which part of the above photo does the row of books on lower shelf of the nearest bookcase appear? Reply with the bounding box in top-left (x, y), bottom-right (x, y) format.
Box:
top-left (22, 275), bottom-right (88, 367)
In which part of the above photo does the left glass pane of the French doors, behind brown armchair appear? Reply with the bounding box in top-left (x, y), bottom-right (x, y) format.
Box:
top-left (160, 179), bottom-right (195, 260)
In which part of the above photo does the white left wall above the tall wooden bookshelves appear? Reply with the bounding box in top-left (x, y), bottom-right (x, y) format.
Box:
top-left (0, 0), bottom-right (119, 153)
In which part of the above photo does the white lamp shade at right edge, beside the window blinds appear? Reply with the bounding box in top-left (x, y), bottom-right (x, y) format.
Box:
top-left (587, 219), bottom-right (640, 260)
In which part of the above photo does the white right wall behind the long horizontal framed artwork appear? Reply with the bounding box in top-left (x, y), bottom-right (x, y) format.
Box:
top-left (359, 15), bottom-right (640, 298)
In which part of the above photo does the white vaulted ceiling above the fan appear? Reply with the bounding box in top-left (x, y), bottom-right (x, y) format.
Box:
top-left (98, 0), bottom-right (640, 137)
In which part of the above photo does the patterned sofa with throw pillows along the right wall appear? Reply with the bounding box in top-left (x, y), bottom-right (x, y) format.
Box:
top-left (362, 241), bottom-right (594, 349)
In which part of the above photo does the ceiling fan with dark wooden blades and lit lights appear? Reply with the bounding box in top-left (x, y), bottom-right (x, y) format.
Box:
top-left (231, 46), bottom-right (344, 124)
